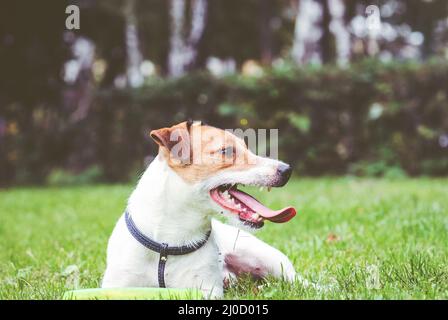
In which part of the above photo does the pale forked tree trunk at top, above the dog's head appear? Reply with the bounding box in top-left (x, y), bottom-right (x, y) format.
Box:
top-left (168, 0), bottom-right (207, 77)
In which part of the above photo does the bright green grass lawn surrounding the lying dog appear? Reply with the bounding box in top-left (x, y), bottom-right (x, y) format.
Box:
top-left (0, 178), bottom-right (448, 299)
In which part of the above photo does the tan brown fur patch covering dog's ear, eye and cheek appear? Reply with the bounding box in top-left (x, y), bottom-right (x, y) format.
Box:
top-left (150, 122), bottom-right (257, 183)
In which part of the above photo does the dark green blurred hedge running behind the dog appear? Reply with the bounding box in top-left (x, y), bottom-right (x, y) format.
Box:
top-left (0, 61), bottom-right (448, 182)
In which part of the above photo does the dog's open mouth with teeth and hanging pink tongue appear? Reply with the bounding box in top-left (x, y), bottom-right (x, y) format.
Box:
top-left (210, 185), bottom-right (296, 229)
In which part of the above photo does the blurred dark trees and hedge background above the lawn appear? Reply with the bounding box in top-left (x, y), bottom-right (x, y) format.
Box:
top-left (0, 0), bottom-right (448, 185)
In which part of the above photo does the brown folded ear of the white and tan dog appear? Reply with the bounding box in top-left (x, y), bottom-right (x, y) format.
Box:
top-left (150, 122), bottom-right (191, 165)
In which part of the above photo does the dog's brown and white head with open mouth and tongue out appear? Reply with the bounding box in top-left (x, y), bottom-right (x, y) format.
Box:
top-left (151, 122), bottom-right (296, 228)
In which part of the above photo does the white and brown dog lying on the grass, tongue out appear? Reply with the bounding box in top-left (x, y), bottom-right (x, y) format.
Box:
top-left (102, 121), bottom-right (296, 298)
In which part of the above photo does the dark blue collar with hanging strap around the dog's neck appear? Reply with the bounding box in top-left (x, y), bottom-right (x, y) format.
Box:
top-left (125, 211), bottom-right (211, 288)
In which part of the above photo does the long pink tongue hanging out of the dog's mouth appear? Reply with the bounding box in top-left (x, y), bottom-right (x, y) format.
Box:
top-left (229, 189), bottom-right (296, 223)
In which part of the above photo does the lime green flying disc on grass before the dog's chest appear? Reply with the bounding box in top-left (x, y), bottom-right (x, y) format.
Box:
top-left (63, 288), bottom-right (204, 300)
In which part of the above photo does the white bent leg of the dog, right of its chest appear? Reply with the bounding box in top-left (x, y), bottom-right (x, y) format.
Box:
top-left (213, 220), bottom-right (296, 282)
